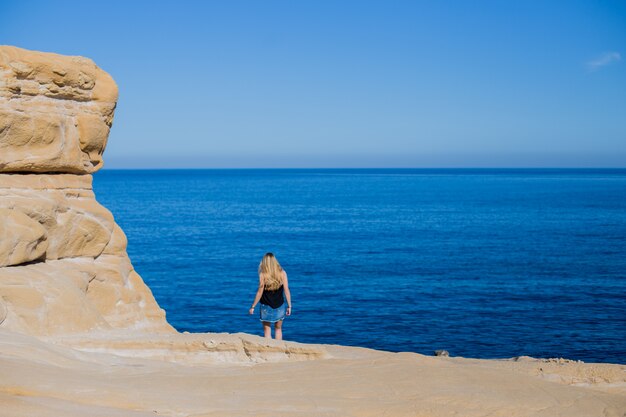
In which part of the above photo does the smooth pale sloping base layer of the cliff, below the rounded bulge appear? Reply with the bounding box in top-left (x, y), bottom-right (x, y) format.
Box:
top-left (0, 255), bottom-right (173, 335)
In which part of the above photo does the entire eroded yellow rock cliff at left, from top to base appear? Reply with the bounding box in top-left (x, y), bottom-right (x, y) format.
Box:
top-left (0, 46), bottom-right (173, 335)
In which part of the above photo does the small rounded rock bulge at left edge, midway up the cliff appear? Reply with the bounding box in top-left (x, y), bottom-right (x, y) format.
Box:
top-left (0, 209), bottom-right (48, 267)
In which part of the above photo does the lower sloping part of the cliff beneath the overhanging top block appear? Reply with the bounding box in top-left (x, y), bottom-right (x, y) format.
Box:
top-left (0, 174), bottom-right (173, 335)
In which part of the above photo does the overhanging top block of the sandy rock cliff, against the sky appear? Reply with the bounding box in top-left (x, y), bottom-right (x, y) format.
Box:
top-left (0, 46), bottom-right (117, 174)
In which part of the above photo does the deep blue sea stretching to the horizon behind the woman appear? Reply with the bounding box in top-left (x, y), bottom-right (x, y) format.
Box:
top-left (94, 169), bottom-right (626, 363)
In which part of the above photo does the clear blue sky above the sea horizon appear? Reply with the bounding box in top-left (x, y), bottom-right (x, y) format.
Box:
top-left (0, 0), bottom-right (626, 168)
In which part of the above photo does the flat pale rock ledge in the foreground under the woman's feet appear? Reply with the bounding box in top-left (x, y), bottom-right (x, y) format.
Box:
top-left (0, 329), bottom-right (626, 417)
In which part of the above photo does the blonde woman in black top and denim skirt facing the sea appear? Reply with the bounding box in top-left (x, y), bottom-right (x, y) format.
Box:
top-left (248, 252), bottom-right (291, 340)
